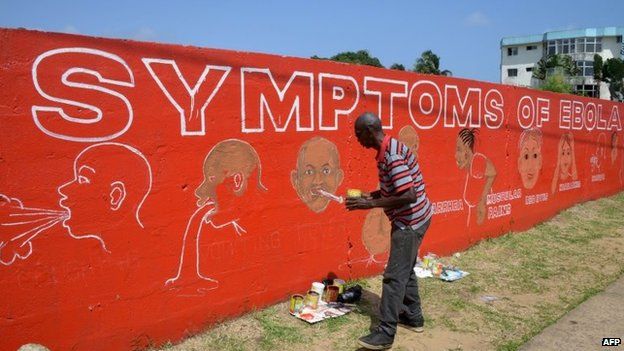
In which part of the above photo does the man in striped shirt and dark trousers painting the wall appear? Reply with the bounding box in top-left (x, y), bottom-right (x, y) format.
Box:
top-left (346, 113), bottom-right (433, 350)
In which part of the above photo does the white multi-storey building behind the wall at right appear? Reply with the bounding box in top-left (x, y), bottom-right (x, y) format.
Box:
top-left (500, 27), bottom-right (624, 99)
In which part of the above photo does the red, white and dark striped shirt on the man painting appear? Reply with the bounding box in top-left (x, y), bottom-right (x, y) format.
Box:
top-left (377, 135), bottom-right (433, 229)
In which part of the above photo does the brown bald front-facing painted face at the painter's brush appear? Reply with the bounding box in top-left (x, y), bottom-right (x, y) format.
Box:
top-left (291, 139), bottom-right (343, 213)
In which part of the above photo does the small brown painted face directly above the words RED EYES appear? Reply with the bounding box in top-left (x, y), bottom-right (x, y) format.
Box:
top-left (518, 128), bottom-right (542, 189)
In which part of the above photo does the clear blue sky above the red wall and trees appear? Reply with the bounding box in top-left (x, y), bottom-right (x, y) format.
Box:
top-left (0, 0), bottom-right (624, 82)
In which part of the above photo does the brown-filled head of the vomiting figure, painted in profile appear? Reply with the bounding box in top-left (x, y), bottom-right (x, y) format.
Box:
top-left (195, 139), bottom-right (267, 207)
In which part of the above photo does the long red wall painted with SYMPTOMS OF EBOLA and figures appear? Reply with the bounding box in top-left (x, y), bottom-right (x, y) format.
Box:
top-left (0, 29), bottom-right (624, 350)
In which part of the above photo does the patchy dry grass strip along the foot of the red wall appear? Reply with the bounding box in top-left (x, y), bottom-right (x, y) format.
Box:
top-left (154, 193), bottom-right (624, 351)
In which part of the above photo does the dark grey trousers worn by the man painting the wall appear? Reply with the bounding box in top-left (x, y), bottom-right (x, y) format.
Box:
top-left (379, 219), bottom-right (431, 336)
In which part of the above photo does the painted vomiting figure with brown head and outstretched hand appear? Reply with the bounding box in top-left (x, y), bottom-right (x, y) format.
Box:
top-left (165, 139), bottom-right (267, 297)
